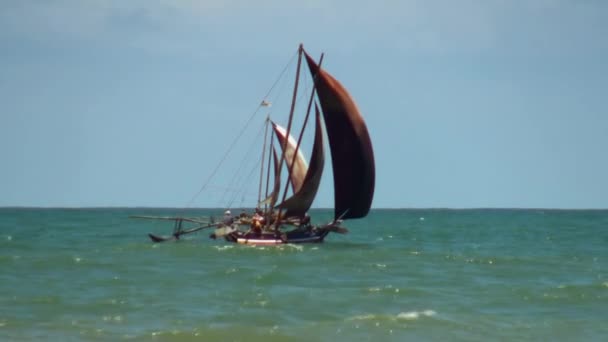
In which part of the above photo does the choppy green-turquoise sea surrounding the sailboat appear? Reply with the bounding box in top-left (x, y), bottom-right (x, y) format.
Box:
top-left (0, 208), bottom-right (608, 342)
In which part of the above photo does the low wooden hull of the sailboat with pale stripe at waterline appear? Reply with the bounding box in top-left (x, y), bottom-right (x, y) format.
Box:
top-left (224, 229), bottom-right (329, 246)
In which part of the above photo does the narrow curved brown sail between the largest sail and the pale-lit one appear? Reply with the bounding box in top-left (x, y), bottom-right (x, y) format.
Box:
top-left (278, 107), bottom-right (325, 217)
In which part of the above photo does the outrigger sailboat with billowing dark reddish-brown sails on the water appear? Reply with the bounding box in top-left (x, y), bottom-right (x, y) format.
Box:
top-left (140, 45), bottom-right (375, 245)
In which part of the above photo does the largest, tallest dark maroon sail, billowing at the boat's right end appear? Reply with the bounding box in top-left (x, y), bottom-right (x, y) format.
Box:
top-left (304, 53), bottom-right (375, 219)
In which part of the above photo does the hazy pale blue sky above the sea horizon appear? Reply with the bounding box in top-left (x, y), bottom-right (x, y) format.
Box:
top-left (0, 0), bottom-right (608, 209)
